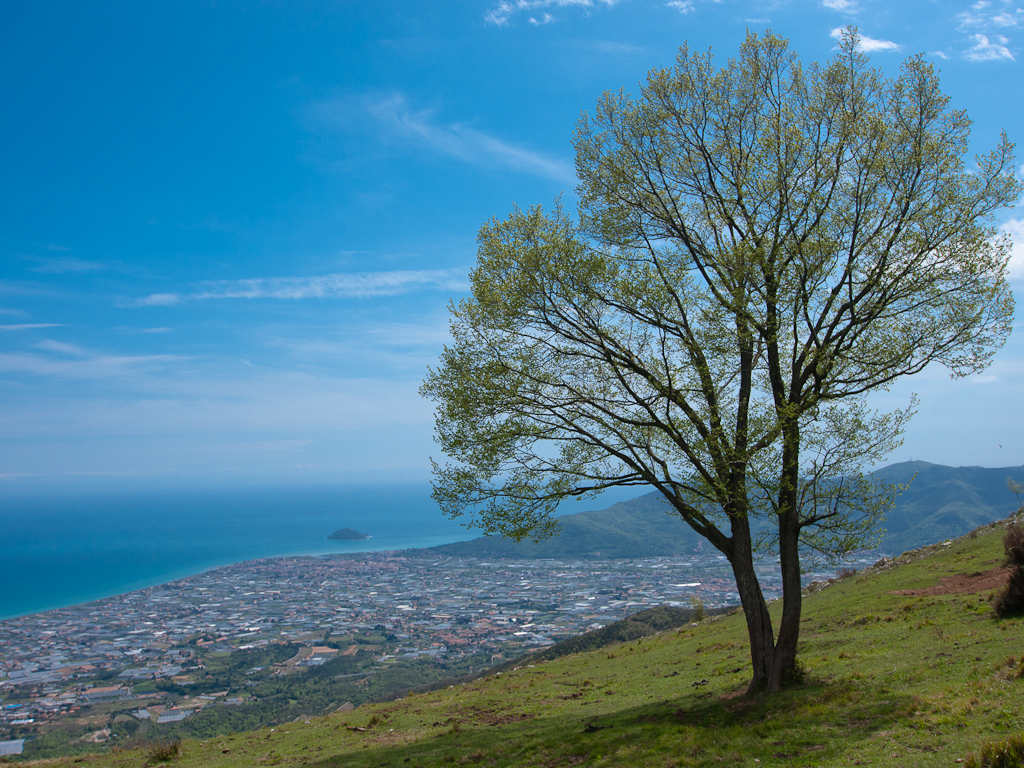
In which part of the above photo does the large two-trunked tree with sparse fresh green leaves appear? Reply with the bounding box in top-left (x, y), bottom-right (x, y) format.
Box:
top-left (422, 29), bottom-right (1022, 691)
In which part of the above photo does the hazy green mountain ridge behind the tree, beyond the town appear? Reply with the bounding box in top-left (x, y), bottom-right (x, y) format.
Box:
top-left (420, 462), bottom-right (1024, 559)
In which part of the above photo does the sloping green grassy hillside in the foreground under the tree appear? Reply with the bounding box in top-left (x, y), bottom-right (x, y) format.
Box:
top-left (25, 512), bottom-right (1024, 768)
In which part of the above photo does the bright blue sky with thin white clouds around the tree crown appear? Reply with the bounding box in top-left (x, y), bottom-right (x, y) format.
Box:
top-left (0, 0), bottom-right (1024, 488)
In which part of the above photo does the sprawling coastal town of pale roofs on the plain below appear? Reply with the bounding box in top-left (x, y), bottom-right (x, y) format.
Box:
top-left (0, 552), bottom-right (868, 753)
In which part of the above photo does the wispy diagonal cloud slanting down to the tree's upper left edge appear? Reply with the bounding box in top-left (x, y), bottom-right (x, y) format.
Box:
top-left (369, 94), bottom-right (577, 186)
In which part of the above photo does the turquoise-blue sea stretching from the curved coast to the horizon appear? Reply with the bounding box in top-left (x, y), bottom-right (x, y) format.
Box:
top-left (0, 482), bottom-right (642, 621)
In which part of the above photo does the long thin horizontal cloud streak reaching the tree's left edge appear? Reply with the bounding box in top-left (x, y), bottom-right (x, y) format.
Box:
top-left (130, 269), bottom-right (469, 306)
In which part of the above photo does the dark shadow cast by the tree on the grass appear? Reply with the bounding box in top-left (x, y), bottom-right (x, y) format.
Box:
top-left (308, 681), bottom-right (919, 768)
